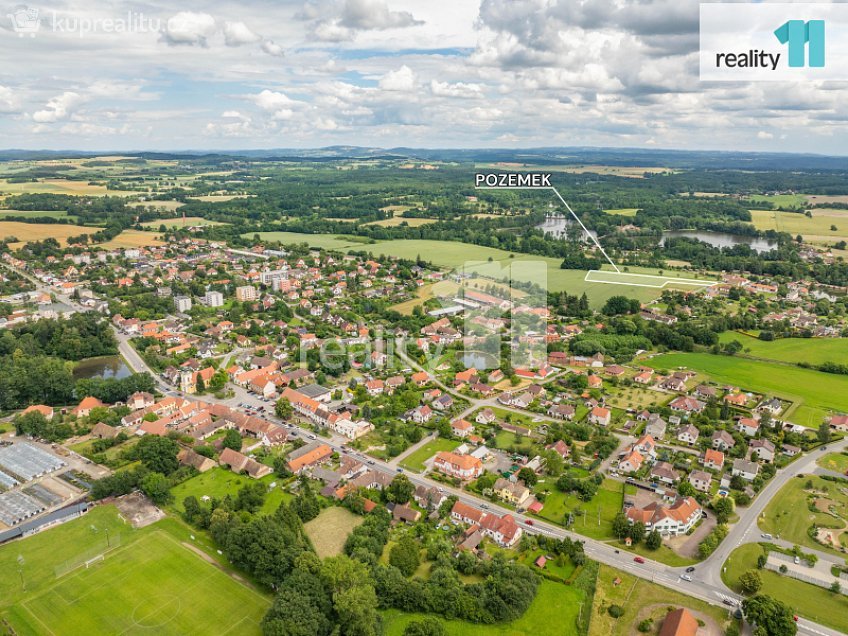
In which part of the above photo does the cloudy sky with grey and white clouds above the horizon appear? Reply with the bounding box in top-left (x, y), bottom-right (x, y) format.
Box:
top-left (0, 0), bottom-right (848, 155)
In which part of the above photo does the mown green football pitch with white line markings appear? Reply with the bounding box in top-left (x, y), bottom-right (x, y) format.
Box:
top-left (7, 530), bottom-right (268, 636)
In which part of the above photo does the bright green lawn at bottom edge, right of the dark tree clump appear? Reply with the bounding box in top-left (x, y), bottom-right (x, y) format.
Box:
top-left (383, 580), bottom-right (586, 636)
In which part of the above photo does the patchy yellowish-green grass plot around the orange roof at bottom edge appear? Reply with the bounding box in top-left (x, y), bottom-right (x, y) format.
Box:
top-left (589, 564), bottom-right (729, 636)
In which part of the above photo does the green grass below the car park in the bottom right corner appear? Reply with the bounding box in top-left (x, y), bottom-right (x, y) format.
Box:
top-left (721, 543), bottom-right (848, 633)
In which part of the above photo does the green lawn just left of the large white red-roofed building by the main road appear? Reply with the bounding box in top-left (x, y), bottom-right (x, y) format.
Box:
top-left (535, 479), bottom-right (624, 540)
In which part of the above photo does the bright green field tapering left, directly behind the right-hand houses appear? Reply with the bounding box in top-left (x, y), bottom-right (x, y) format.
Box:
top-left (646, 353), bottom-right (848, 428)
